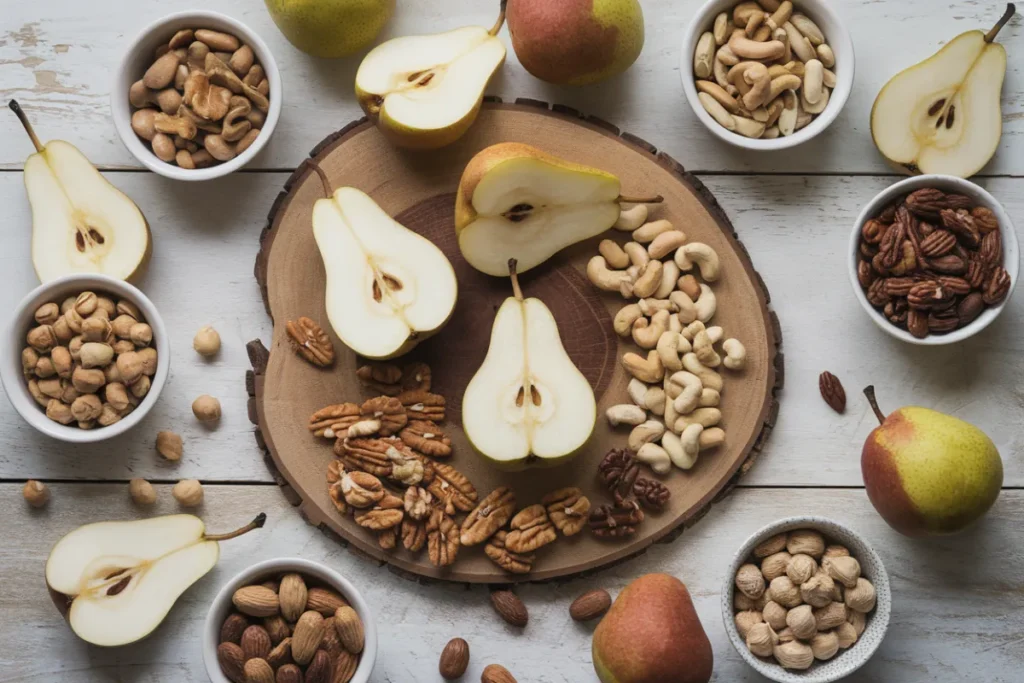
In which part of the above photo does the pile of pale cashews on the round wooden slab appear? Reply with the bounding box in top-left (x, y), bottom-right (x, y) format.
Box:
top-left (587, 205), bottom-right (746, 474)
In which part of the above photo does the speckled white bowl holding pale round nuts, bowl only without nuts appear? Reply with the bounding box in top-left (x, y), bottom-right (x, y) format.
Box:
top-left (722, 517), bottom-right (892, 683)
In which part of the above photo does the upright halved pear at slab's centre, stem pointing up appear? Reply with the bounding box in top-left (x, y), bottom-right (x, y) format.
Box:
top-left (462, 259), bottom-right (597, 470)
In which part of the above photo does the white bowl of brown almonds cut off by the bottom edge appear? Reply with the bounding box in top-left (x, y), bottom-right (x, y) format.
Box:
top-left (203, 558), bottom-right (377, 683)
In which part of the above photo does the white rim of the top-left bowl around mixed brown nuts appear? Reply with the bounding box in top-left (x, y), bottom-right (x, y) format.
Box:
top-left (111, 9), bottom-right (284, 181)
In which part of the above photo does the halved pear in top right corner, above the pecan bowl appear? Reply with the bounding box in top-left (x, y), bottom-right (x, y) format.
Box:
top-left (871, 5), bottom-right (1015, 178)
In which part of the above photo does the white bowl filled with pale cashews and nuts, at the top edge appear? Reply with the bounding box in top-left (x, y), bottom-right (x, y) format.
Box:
top-left (681, 0), bottom-right (854, 150)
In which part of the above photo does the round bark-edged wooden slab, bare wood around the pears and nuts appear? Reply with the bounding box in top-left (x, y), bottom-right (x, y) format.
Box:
top-left (248, 100), bottom-right (782, 584)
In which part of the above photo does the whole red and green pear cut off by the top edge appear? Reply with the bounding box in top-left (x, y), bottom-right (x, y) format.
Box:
top-left (506, 0), bottom-right (643, 85)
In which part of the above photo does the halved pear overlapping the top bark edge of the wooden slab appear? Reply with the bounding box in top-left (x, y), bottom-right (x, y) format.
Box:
top-left (355, 11), bottom-right (506, 150)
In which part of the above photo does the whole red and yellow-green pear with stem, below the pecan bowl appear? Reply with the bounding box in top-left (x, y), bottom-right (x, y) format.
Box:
top-left (860, 387), bottom-right (1002, 537)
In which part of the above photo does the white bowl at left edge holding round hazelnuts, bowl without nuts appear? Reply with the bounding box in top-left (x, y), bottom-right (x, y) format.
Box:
top-left (0, 274), bottom-right (171, 443)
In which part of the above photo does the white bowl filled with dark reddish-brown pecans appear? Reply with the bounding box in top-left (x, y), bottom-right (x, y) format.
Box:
top-left (849, 175), bottom-right (1020, 345)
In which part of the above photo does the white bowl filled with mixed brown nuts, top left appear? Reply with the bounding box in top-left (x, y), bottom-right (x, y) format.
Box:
top-left (111, 11), bottom-right (282, 180)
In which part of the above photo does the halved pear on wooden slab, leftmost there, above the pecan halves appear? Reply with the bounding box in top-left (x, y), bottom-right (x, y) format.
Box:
top-left (312, 179), bottom-right (458, 358)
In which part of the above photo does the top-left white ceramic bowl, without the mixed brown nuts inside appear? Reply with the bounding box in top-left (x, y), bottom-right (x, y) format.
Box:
top-left (111, 10), bottom-right (284, 180)
